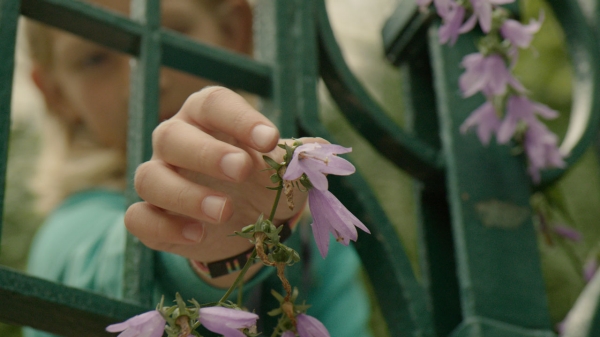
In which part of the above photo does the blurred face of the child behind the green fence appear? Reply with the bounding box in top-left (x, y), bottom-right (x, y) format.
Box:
top-left (33, 0), bottom-right (251, 148)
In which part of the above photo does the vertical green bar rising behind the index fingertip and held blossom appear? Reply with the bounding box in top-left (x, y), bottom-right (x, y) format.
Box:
top-left (255, 0), bottom-right (318, 335)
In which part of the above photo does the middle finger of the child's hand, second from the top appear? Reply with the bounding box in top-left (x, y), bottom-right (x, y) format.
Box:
top-left (152, 120), bottom-right (252, 182)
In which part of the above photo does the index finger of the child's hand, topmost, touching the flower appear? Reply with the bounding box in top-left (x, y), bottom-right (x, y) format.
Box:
top-left (173, 87), bottom-right (279, 152)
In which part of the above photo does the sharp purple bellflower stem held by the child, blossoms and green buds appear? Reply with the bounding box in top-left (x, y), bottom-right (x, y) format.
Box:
top-left (106, 141), bottom-right (369, 337)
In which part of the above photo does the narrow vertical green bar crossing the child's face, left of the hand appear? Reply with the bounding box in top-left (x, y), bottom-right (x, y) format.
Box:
top-left (123, 0), bottom-right (161, 307)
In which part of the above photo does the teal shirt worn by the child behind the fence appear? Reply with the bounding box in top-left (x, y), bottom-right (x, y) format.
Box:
top-left (24, 190), bottom-right (371, 337)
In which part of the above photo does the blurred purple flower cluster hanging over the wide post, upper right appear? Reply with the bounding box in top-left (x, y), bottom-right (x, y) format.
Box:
top-left (417, 0), bottom-right (565, 182)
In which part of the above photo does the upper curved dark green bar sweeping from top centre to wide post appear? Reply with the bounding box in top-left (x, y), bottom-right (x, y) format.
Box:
top-left (318, 1), bottom-right (443, 181)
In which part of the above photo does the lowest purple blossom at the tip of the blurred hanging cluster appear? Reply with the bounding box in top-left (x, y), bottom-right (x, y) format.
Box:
top-left (524, 120), bottom-right (565, 183)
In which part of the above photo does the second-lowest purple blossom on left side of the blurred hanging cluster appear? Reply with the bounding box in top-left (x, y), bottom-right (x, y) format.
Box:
top-left (459, 53), bottom-right (525, 97)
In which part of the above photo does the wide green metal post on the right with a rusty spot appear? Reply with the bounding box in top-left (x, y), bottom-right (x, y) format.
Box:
top-left (429, 23), bottom-right (553, 337)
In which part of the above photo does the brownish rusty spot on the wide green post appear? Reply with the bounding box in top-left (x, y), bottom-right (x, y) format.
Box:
top-left (475, 199), bottom-right (531, 229)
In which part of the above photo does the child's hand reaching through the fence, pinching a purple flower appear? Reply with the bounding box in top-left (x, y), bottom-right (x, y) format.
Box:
top-left (125, 87), bottom-right (316, 280)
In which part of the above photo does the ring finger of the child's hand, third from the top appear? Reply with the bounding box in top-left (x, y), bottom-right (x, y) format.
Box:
top-left (135, 160), bottom-right (233, 223)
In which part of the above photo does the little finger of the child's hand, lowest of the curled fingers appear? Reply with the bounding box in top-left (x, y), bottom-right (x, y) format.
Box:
top-left (125, 202), bottom-right (205, 251)
